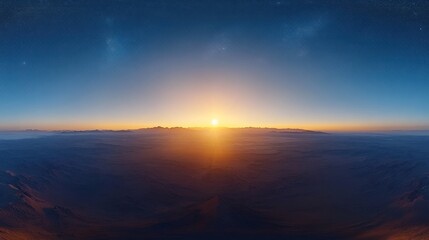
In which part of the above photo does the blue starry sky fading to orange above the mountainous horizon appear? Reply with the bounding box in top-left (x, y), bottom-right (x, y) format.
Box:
top-left (0, 0), bottom-right (429, 131)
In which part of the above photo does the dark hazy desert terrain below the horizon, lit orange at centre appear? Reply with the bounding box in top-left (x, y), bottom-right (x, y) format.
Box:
top-left (0, 129), bottom-right (429, 240)
